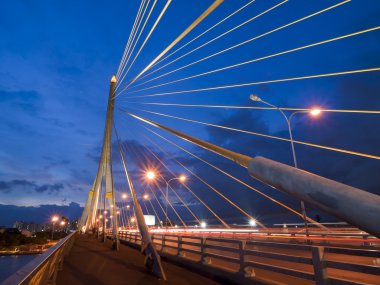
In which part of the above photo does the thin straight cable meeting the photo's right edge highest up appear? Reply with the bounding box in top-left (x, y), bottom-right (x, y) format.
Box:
top-left (129, 26), bottom-right (380, 94)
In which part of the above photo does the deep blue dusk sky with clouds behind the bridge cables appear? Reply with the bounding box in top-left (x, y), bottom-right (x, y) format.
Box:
top-left (0, 0), bottom-right (380, 226)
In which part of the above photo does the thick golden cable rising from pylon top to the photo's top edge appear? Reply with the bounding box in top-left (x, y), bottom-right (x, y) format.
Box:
top-left (115, 0), bottom-right (224, 98)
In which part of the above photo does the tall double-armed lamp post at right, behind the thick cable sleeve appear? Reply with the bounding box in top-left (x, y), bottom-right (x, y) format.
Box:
top-left (249, 94), bottom-right (322, 237)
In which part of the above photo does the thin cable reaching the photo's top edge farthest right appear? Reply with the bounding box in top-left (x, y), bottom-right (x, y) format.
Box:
top-left (123, 0), bottom-right (351, 92)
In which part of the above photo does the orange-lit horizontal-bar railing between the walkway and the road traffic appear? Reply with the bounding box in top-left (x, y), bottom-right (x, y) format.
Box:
top-left (120, 231), bottom-right (380, 284)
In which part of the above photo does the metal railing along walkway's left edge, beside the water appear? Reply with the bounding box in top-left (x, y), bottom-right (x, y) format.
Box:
top-left (1, 232), bottom-right (78, 285)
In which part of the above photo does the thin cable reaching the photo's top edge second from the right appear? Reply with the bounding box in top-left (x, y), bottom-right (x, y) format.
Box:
top-left (128, 0), bottom-right (288, 86)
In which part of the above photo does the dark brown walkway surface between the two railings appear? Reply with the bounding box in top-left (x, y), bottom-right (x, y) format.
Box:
top-left (57, 235), bottom-right (221, 285)
